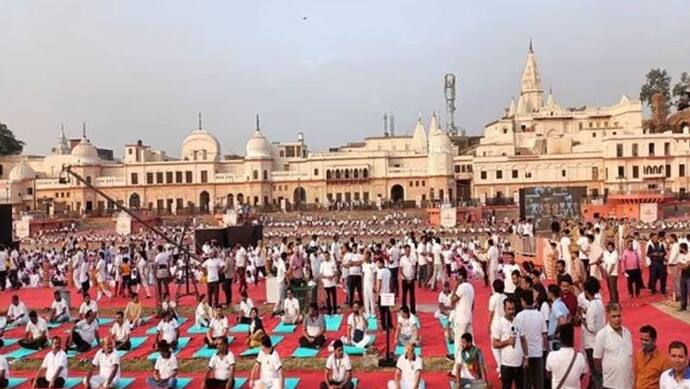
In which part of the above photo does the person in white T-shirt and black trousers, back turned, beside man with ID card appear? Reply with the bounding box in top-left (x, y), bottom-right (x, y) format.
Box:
top-left (514, 292), bottom-right (548, 389)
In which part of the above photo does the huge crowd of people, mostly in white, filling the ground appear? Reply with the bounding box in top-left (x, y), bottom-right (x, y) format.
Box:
top-left (0, 214), bottom-right (690, 389)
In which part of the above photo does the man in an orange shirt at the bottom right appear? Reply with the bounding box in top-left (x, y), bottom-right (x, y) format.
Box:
top-left (633, 325), bottom-right (671, 388)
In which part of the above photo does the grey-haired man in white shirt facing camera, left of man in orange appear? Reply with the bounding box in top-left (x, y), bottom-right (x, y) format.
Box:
top-left (593, 304), bottom-right (633, 388)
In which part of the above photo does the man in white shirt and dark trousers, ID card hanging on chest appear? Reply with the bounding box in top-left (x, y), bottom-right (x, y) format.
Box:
top-left (491, 298), bottom-right (524, 389)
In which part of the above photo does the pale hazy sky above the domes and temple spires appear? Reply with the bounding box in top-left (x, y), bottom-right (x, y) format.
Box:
top-left (0, 0), bottom-right (690, 155)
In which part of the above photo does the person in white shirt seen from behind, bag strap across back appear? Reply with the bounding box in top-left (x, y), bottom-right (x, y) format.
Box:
top-left (546, 323), bottom-right (589, 389)
